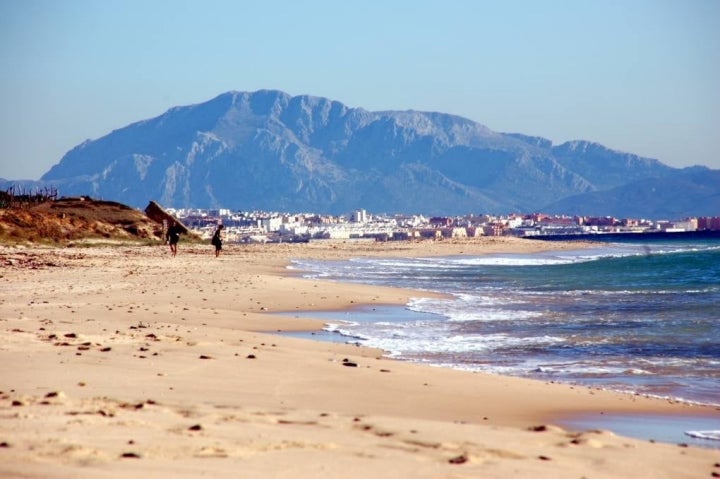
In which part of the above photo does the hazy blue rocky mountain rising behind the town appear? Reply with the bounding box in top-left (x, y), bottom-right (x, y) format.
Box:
top-left (0, 90), bottom-right (720, 219)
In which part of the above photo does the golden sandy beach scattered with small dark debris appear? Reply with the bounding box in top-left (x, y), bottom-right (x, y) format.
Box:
top-left (0, 238), bottom-right (720, 478)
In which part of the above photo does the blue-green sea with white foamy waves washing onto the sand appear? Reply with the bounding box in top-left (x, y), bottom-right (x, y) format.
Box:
top-left (292, 238), bottom-right (720, 448)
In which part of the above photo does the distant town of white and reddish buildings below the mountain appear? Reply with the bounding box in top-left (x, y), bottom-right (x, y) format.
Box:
top-left (167, 208), bottom-right (720, 242)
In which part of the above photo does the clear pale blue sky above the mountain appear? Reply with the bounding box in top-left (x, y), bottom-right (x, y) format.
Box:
top-left (0, 0), bottom-right (720, 179)
